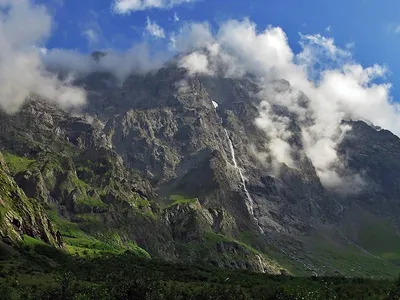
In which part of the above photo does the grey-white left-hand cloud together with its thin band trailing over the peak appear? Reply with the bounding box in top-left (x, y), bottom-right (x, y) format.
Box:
top-left (0, 0), bottom-right (171, 114)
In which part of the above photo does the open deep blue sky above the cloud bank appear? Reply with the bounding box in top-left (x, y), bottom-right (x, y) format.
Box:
top-left (37, 0), bottom-right (400, 99)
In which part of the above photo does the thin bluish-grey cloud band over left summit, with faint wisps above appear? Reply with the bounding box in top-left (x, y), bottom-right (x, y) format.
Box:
top-left (40, 12), bottom-right (172, 84)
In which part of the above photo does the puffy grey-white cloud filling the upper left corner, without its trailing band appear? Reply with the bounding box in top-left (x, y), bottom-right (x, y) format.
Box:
top-left (0, 0), bottom-right (86, 113)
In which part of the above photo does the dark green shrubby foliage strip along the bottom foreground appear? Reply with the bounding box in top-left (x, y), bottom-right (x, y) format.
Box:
top-left (0, 243), bottom-right (400, 300)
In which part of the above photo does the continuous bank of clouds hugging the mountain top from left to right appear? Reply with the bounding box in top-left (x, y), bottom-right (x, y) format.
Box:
top-left (0, 0), bottom-right (400, 189)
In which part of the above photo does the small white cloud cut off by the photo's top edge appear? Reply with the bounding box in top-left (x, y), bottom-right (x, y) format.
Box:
top-left (112, 0), bottom-right (196, 14)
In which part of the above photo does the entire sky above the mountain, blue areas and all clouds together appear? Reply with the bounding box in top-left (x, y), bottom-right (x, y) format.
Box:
top-left (0, 0), bottom-right (400, 182)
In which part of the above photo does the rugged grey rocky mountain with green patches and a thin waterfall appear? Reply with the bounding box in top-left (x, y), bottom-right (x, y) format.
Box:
top-left (0, 65), bottom-right (400, 275)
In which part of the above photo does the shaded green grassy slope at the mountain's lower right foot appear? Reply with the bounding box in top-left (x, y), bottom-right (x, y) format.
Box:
top-left (248, 206), bottom-right (400, 278)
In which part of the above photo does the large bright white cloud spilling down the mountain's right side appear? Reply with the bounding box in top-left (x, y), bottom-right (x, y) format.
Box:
top-left (174, 19), bottom-right (400, 190)
